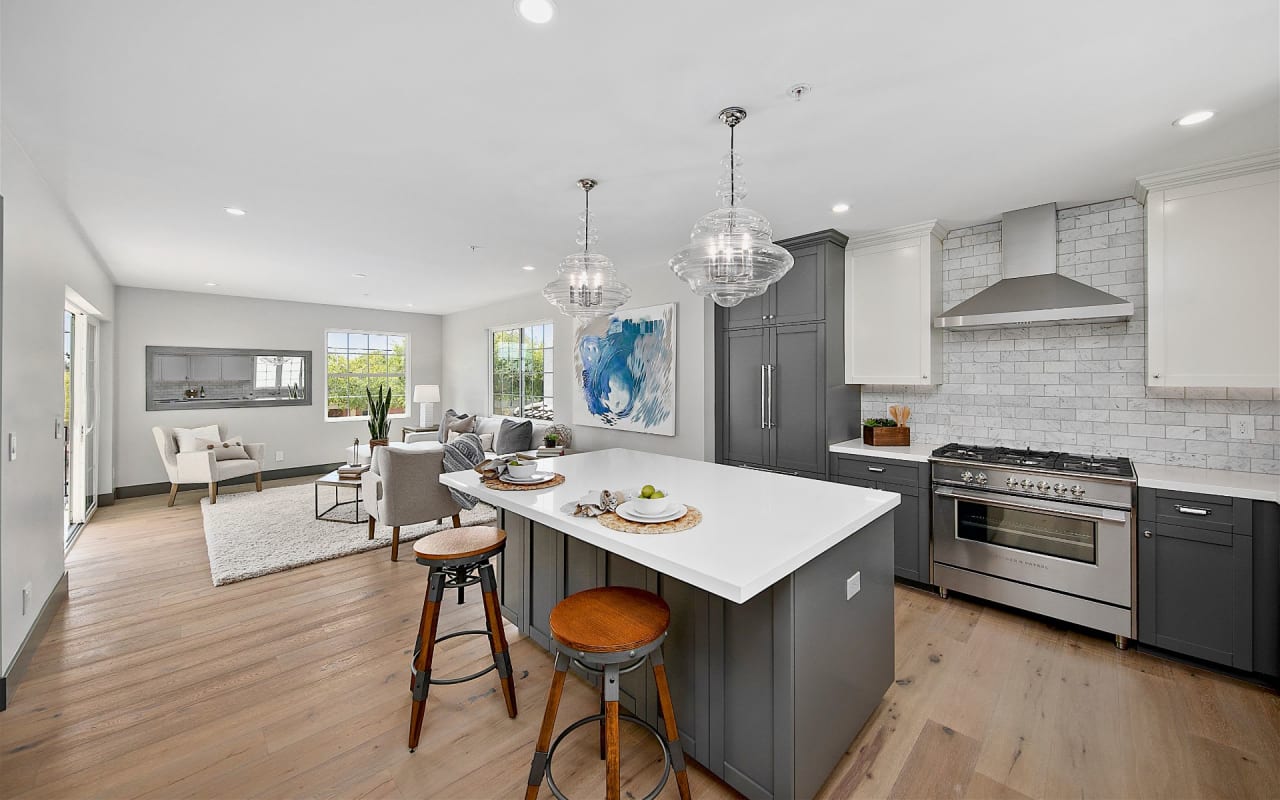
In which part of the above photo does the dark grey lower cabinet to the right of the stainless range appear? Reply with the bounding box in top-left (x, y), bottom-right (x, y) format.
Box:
top-left (1138, 489), bottom-right (1280, 676)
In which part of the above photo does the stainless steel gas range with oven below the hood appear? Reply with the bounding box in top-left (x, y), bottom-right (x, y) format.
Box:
top-left (929, 444), bottom-right (1137, 648)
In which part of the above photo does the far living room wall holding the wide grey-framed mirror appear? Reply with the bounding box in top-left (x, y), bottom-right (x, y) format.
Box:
top-left (115, 287), bottom-right (442, 486)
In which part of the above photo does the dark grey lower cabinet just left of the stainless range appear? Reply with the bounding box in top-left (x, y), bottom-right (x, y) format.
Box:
top-left (831, 453), bottom-right (932, 584)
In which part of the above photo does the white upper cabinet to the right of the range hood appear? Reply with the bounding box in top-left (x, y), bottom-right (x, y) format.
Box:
top-left (1138, 151), bottom-right (1280, 387)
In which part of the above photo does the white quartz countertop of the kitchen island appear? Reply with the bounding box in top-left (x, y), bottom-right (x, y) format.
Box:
top-left (440, 449), bottom-right (901, 603)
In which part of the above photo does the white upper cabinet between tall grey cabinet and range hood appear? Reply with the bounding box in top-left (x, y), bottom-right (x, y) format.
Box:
top-left (845, 220), bottom-right (946, 385)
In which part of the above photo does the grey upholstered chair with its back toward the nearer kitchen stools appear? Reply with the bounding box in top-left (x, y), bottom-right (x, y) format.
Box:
top-left (360, 444), bottom-right (462, 561)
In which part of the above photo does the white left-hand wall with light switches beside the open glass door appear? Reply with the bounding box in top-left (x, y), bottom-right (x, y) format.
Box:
top-left (0, 128), bottom-right (115, 672)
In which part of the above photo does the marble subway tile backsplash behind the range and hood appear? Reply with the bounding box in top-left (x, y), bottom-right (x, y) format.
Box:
top-left (863, 197), bottom-right (1280, 475)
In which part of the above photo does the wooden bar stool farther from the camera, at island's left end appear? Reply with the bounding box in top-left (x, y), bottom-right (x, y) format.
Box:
top-left (408, 526), bottom-right (516, 753)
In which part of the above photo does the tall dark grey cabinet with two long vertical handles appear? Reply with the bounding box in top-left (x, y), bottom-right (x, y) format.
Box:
top-left (716, 230), bottom-right (859, 479)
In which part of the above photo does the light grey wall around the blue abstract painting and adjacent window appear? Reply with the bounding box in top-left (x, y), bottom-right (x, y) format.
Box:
top-left (440, 266), bottom-right (716, 461)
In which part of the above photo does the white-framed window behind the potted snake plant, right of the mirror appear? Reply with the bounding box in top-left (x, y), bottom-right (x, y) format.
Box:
top-left (324, 330), bottom-right (408, 420)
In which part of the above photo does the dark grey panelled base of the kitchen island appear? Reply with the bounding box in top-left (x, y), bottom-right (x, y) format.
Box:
top-left (499, 509), bottom-right (893, 800)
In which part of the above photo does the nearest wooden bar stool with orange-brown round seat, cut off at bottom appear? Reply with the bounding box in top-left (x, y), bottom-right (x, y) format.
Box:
top-left (525, 586), bottom-right (690, 800)
